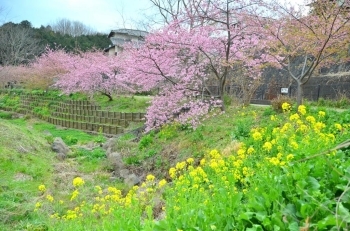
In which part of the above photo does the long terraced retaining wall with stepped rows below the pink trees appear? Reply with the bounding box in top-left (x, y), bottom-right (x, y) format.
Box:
top-left (0, 91), bottom-right (145, 134)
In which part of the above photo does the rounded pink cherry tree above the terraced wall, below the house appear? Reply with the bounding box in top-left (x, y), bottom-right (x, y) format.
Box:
top-left (28, 49), bottom-right (132, 100)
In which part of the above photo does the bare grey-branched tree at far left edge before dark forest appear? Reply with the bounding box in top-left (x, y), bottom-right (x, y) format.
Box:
top-left (0, 22), bottom-right (42, 66)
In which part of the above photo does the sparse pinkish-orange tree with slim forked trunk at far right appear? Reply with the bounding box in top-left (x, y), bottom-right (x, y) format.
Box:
top-left (255, 0), bottom-right (350, 105)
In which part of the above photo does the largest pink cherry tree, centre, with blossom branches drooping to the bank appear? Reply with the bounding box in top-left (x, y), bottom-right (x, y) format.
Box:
top-left (123, 1), bottom-right (272, 129)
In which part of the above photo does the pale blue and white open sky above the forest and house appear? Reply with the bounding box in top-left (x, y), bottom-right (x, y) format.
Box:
top-left (0, 0), bottom-right (151, 33)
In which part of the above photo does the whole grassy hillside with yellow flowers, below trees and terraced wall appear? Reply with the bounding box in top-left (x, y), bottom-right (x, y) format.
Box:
top-left (0, 100), bottom-right (350, 230)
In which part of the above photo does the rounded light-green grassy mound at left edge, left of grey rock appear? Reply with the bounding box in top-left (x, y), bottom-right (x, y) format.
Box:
top-left (0, 119), bottom-right (55, 230)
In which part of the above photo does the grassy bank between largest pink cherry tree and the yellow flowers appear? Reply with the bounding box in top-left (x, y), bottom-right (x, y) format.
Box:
top-left (115, 106), bottom-right (270, 178)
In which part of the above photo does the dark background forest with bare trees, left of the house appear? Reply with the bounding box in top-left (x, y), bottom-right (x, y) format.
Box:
top-left (0, 19), bottom-right (110, 66)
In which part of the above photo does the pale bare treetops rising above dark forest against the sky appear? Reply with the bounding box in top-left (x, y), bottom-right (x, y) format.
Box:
top-left (51, 18), bottom-right (93, 37)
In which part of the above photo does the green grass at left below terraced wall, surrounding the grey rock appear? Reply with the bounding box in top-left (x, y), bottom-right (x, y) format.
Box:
top-left (0, 118), bottom-right (115, 231)
